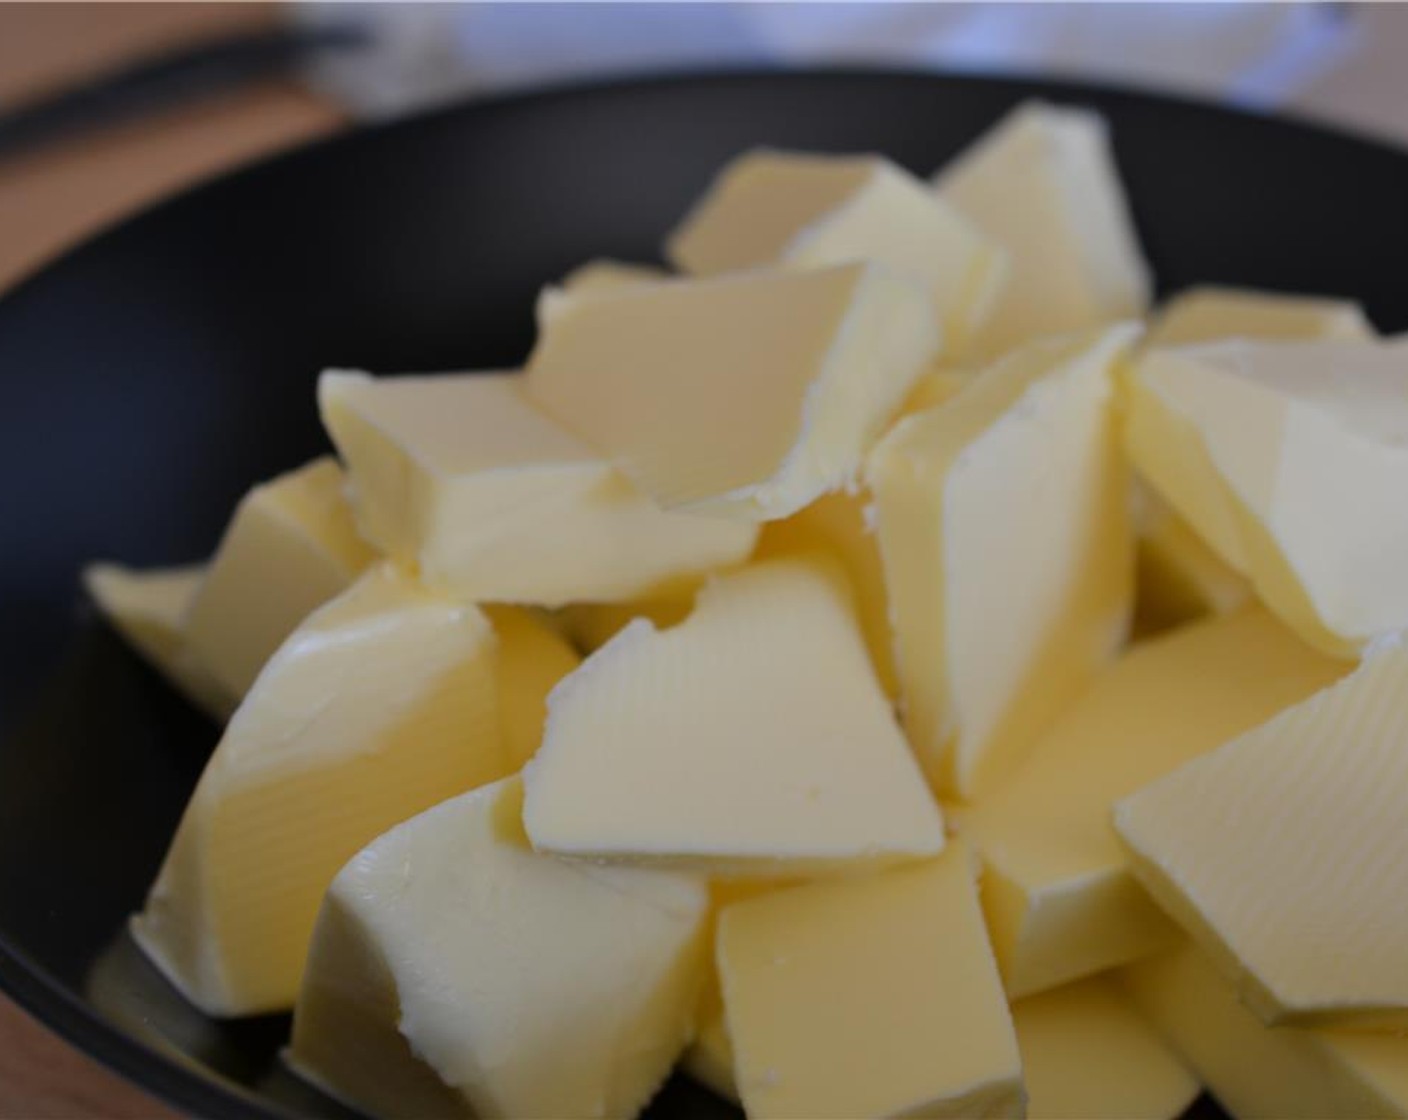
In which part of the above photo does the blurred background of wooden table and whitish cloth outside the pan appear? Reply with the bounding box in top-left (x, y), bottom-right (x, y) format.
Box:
top-left (0, 0), bottom-right (1408, 1117)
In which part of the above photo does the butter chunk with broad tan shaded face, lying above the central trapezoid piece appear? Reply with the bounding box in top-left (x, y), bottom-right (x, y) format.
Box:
top-left (528, 263), bottom-right (939, 521)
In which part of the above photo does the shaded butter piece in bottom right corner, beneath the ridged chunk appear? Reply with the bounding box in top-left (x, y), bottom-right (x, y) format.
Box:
top-left (1124, 944), bottom-right (1408, 1120)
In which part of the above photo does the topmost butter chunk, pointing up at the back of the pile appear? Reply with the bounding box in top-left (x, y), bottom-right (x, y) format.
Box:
top-left (935, 101), bottom-right (1150, 358)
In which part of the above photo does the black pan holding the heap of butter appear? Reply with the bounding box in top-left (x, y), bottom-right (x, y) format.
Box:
top-left (0, 72), bottom-right (1408, 1119)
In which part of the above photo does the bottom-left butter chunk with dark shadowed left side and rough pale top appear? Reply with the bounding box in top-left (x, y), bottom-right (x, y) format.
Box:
top-left (286, 779), bottom-right (708, 1120)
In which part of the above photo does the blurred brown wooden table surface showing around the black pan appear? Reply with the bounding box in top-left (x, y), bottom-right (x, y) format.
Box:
top-left (0, 3), bottom-right (345, 1120)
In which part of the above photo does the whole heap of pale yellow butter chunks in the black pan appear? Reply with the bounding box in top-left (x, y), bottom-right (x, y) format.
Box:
top-left (89, 103), bottom-right (1408, 1120)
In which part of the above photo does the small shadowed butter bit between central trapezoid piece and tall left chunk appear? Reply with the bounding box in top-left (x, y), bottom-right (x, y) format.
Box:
top-left (484, 606), bottom-right (582, 772)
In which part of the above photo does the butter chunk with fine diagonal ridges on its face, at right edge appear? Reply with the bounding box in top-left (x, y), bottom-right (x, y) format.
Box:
top-left (1115, 647), bottom-right (1408, 1027)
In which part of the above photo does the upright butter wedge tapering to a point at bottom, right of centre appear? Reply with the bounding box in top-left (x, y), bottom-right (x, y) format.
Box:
top-left (866, 327), bottom-right (1133, 796)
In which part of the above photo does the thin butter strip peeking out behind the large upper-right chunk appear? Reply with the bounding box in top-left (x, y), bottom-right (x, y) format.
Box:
top-left (1145, 285), bottom-right (1374, 349)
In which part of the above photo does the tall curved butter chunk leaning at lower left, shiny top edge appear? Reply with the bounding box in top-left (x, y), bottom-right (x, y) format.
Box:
top-left (132, 565), bottom-right (508, 1016)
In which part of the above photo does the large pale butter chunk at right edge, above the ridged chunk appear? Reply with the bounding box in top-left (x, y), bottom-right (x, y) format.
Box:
top-left (1125, 341), bottom-right (1408, 657)
